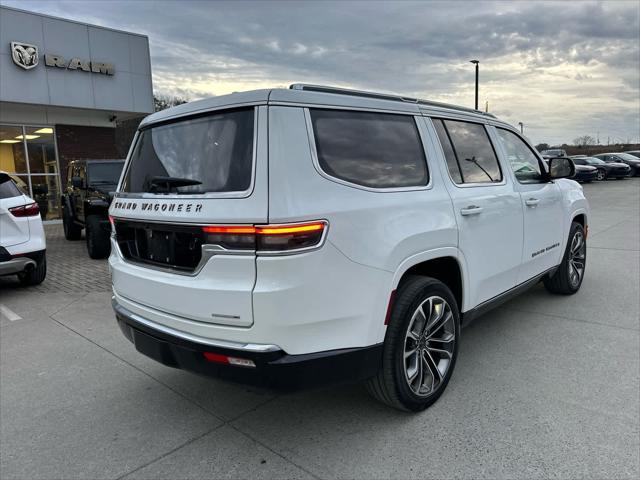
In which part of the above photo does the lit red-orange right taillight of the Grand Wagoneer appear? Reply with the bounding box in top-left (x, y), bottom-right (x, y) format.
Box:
top-left (202, 220), bottom-right (327, 252)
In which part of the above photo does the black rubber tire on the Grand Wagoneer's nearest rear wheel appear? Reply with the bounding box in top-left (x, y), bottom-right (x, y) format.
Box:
top-left (366, 276), bottom-right (460, 412)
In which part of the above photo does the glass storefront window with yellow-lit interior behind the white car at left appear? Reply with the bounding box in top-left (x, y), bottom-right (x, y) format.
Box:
top-left (0, 125), bottom-right (60, 220)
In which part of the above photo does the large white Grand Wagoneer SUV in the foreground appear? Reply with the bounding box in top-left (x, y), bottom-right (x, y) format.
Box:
top-left (109, 85), bottom-right (589, 411)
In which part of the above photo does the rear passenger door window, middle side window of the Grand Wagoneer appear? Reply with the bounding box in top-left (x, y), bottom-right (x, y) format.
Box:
top-left (434, 119), bottom-right (502, 184)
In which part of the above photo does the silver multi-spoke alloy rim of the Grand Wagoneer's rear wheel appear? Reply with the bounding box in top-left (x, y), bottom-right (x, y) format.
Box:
top-left (404, 296), bottom-right (456, 397)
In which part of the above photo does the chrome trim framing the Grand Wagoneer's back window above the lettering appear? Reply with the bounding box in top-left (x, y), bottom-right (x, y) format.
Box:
top-left (114, 105), bottom-right (260, 200)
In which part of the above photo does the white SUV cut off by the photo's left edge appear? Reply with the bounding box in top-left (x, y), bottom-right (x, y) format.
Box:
top-left (0, 172), bottom-right (47, 285)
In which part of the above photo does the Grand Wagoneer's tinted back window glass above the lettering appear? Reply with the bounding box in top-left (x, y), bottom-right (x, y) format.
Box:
top-left (122, 108), bottom-right (254, 194)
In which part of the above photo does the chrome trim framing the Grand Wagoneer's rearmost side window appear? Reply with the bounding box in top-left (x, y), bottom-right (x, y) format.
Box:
top-left (304, 105), bottom-right (433, 193)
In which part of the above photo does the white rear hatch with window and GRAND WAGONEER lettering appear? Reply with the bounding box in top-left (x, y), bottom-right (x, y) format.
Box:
top-left (110, 106), bottom-right (268, 327)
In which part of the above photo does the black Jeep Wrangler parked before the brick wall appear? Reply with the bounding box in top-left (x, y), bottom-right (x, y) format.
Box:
top-left (62, 160), bottom-right (124, 258)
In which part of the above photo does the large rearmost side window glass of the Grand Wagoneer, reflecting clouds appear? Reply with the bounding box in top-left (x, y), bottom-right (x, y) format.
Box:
top-left (310, 109), bottom-right (429, 188)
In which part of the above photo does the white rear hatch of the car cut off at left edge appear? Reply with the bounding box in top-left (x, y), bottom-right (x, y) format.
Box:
top-left (0, 172), bottom-right (33, 247)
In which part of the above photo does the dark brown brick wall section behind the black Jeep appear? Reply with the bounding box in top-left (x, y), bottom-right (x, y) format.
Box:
top-left (56, 125), bottom-right (120, 184)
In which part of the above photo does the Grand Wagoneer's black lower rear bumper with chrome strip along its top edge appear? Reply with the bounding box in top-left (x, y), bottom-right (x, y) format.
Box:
top-left (112, 299), bottom-right (382, 390)
